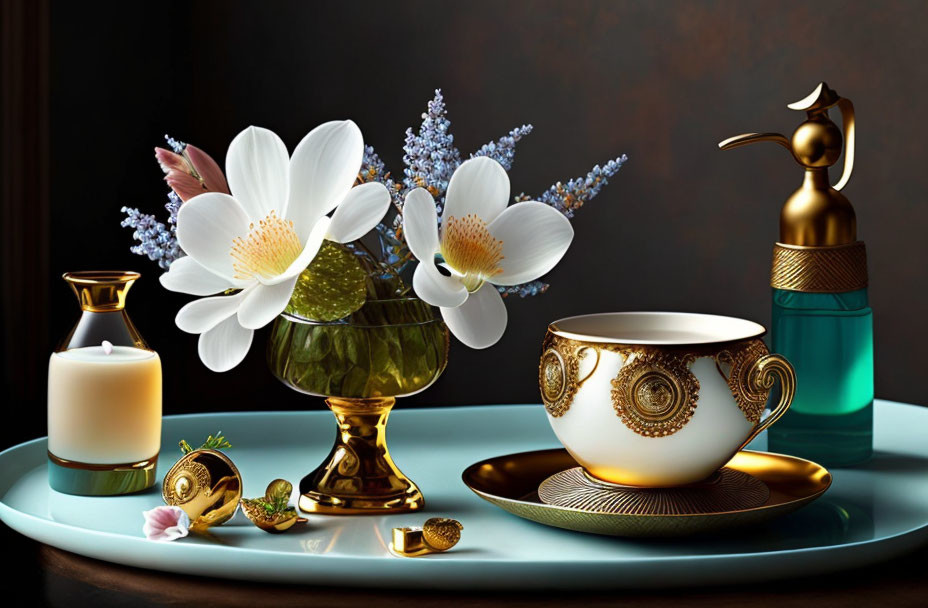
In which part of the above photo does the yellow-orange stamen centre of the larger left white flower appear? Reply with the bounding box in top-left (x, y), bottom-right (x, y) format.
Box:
top-left (231, 211), bottom-right (303, 280)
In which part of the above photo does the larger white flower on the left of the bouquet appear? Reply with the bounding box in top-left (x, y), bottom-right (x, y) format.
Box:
top-left (161, 120), bottom-right (390, 372)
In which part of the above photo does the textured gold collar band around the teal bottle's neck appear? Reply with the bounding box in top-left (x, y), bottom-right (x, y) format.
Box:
top-left (770, 241), bottom-right (867, 293)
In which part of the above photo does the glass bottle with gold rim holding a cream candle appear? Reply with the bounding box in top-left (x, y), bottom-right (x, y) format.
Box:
top-left (48, 271), bottom-right (161, 496)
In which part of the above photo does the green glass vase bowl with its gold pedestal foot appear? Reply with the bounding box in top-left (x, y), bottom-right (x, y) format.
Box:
top-left (268, 298), bottom-right (449, 514)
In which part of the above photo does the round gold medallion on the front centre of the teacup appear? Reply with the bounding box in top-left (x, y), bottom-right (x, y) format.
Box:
top-left (612, 351), bottom-right (699, 437)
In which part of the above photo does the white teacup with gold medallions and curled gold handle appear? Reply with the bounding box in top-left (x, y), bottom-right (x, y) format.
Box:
top-left (539, 312), bottom-right (796, 487)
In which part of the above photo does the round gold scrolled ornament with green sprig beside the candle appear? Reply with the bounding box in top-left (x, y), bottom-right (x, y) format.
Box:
top-left (161, 433), bottom-right (242, 532)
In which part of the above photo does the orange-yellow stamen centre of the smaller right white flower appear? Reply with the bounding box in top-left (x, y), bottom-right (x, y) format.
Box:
top-left (441, 214), bottom-right (503, 292)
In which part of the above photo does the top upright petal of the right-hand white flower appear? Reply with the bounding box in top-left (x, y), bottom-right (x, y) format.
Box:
top-left (441, 156), bottom-right (509, 223)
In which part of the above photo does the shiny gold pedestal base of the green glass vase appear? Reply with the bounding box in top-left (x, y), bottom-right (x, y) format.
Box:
top-left (299, 397), bottom-right (425, 515)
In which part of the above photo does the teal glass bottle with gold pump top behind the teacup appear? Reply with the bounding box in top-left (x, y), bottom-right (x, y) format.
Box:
top-left (719, 82), bottom-right (873, 466)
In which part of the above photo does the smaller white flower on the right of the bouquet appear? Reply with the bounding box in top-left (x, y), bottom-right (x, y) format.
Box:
top-left (403, 157), bottom-right (574, 348)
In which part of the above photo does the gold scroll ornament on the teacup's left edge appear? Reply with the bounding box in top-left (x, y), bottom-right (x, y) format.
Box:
top-left (538, 333), bottom-right (599, 418)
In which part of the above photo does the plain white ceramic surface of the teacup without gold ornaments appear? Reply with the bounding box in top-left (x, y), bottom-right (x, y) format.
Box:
top-left (548, 312), bottom-right (784, 486)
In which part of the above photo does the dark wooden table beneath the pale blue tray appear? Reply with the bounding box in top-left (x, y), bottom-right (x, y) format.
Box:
top-left (0, 524), bottom-right (928, 608)
